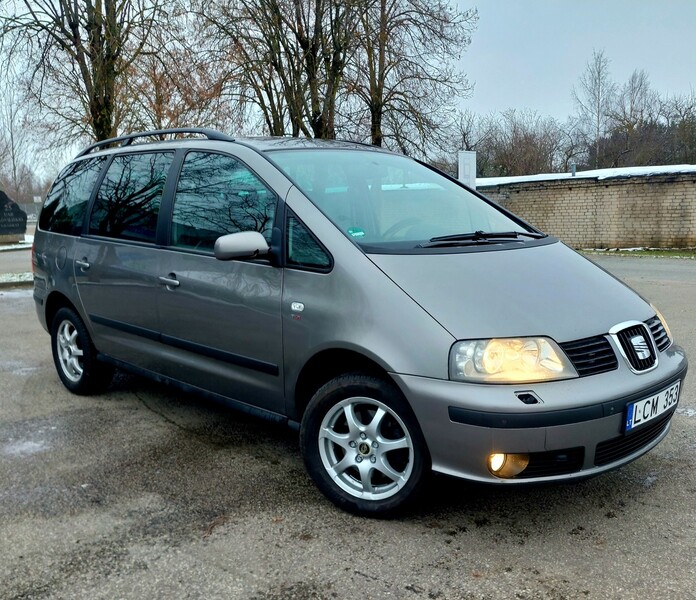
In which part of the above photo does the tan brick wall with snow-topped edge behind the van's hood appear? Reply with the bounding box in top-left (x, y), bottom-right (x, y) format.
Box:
top-left (477, 173), bottom-right (696, 248)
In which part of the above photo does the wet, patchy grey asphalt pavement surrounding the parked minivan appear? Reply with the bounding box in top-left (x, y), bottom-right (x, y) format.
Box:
top-left (0, 257), bottom-right (696, 600)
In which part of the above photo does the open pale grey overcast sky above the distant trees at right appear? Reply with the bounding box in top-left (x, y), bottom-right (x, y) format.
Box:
top-left (460, 0), bottom-right (696, 121)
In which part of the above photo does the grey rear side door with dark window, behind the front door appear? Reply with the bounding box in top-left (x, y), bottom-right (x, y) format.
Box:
top-left (74, 152), bottom-right (174, 371)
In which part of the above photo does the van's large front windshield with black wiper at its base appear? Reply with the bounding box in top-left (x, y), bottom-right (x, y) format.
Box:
top-left (273, 149), bottom-right (530, 250)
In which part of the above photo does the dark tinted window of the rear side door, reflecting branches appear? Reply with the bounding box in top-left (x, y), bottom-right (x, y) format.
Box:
top-left (89, 153), bottom-right (173, 242)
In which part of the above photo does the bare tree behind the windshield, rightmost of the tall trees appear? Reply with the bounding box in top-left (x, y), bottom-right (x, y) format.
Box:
top-left (346, 0), bottom-right (478, 154)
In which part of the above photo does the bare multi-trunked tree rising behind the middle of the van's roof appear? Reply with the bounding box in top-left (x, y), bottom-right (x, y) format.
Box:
top-left (201, 0), bottom-right (358, 138)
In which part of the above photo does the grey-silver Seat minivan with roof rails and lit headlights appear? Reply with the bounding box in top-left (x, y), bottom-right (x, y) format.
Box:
top-left (33, 129), bottom-right (687, 515)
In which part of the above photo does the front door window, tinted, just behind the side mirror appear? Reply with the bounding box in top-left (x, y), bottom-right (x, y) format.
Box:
top-left (172, 152), bottom-right (276, 250)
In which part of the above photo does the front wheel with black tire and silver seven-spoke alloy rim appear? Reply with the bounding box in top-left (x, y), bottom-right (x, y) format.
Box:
top-left (300, 374), bottom-right (430, 516)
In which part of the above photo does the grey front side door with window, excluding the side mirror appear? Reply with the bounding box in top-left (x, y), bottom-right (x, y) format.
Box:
top-left (154, 151), bottom-right (284, 413)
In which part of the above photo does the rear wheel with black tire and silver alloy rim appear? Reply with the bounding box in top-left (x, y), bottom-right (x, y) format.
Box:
top-left (51, 308), bottom-right (114, 396)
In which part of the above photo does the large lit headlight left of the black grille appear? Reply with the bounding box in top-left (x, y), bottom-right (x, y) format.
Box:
top-left (449, 338), bottom-right (578, 383)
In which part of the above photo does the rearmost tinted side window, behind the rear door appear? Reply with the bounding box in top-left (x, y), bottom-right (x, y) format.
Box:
top-left (39, 157), bottom-right (106, 235)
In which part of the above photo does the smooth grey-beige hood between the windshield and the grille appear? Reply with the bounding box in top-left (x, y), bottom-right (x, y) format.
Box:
top-left (369, 242), bottom-right (654, 342)
